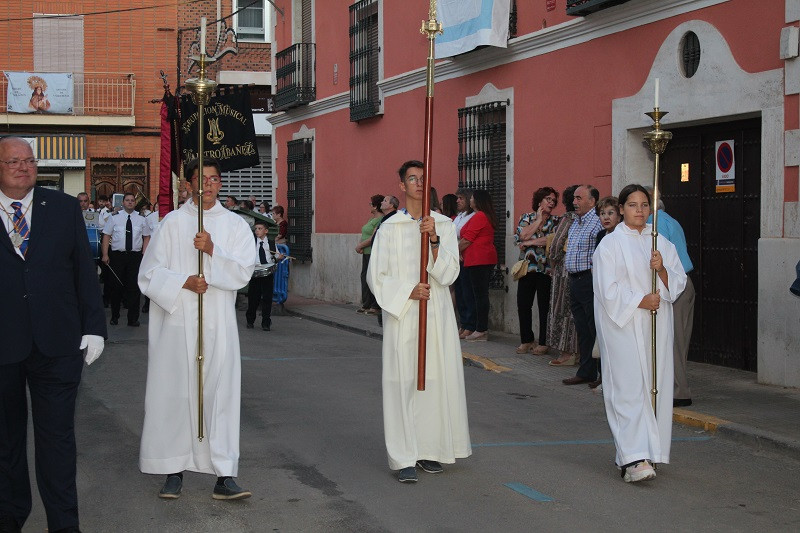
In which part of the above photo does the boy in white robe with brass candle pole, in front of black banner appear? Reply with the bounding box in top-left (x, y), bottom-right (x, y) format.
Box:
top-left (139, 160), bottom-right (254, 500)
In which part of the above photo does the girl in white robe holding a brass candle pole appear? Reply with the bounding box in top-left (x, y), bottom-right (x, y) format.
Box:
top-left (592, 185), bottom-right (686, 482)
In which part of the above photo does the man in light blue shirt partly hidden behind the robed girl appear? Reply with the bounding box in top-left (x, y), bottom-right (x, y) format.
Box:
top-left (645, 187), bottom-right (695, 407)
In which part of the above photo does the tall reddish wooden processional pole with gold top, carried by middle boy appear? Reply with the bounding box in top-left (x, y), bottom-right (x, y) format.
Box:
top-left (417, 0), bottom-right (442, 391)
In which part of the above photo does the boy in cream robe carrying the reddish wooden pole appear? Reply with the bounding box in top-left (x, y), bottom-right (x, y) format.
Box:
top-left (367, 161), bottom-right (472, 482)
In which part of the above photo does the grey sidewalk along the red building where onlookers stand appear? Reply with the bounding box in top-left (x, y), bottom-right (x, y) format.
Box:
top-left (285, 295), bottom-right (800, 460)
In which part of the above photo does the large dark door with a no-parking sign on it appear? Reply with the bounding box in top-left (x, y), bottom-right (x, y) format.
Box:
top-left (660, 118), bottom-right (761, 371)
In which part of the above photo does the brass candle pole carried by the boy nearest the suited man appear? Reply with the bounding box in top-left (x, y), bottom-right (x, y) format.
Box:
top-left (186, 53), bottom-right (217, 442)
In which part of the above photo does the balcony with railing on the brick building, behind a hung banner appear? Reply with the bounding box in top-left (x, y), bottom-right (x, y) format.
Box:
top-left (0, 72), bottom-right (136, 127)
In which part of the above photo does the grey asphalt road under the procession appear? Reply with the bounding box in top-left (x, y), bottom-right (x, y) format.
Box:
top-left (25, 313), bottom-right (800, 532)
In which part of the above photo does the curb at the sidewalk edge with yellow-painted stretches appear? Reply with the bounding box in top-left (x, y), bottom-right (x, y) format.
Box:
top-left (285, 307), bottom-right (800, 461)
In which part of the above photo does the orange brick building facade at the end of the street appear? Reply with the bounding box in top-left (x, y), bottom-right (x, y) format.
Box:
top-left (0, 0), bottom-right (270, 206)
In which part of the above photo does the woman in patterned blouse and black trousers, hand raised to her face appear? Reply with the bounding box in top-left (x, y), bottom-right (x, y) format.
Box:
top-left (514, 187), bottom-right (560, 355)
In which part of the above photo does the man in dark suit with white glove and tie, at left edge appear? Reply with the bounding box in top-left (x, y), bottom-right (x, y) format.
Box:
top-left (0, 137), bottom-right (106, 533)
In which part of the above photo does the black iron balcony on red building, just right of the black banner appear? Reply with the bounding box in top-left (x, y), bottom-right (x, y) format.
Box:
top-left (273, 43), bottom-right (317, 111)
